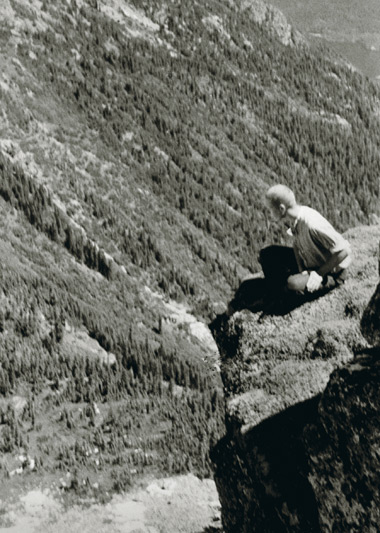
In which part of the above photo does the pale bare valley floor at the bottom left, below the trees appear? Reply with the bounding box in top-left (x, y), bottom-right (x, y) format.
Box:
top-left (0, 475), bottom-right (221, 533)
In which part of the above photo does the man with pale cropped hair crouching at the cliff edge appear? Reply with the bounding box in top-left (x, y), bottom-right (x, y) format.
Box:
top-left (260, 185), bottom-right (351, 294)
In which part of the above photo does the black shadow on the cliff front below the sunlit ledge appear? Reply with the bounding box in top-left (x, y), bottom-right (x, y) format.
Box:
top-left (211, 395), bottom-right (321, 533)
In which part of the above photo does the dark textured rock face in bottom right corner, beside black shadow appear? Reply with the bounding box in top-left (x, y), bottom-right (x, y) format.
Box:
top-left (303, 350), bottom-right (380, 532)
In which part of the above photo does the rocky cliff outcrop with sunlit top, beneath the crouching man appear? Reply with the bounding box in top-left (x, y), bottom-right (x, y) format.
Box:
top-left (212, 226), bottom-right (380, 533)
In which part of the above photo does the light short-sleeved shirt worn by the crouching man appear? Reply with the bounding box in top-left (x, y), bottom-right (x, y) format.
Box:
top-left (292, 205), bottom-right (351, 272)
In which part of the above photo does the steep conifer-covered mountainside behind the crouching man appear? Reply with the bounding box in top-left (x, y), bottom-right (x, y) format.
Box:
top-left (0, 0), bottom-right (380, 498)
